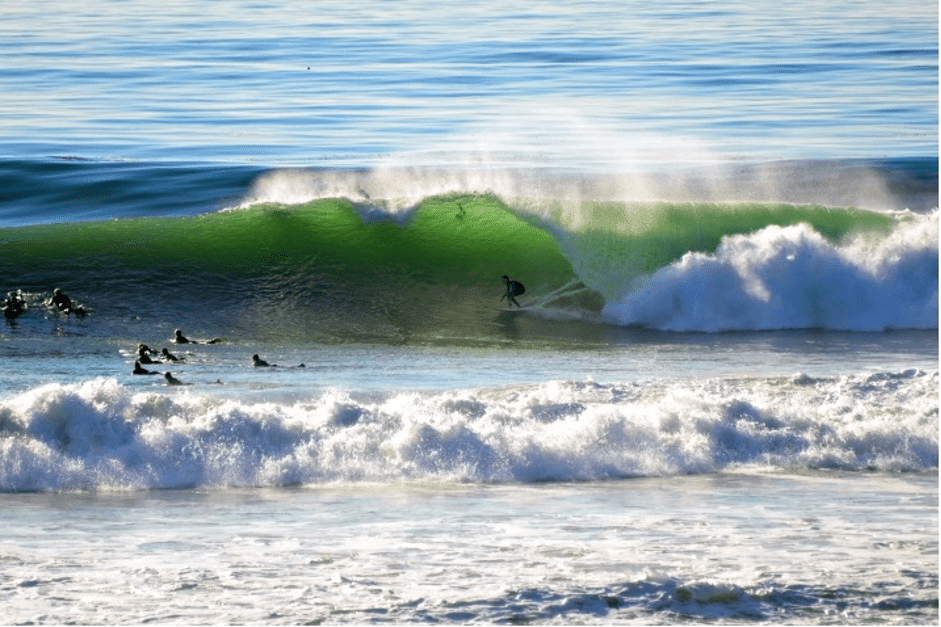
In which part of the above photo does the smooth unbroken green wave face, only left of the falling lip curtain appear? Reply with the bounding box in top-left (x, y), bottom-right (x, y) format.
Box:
top-left (0, 196), bottom-right (574, 336)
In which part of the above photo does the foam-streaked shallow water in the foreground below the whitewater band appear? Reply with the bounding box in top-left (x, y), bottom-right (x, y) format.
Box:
top-left (0, 473), bottom-right (938, 624)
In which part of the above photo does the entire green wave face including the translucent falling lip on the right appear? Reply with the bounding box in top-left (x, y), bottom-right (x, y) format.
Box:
top-left (0, 194), bottom-right (893, 344)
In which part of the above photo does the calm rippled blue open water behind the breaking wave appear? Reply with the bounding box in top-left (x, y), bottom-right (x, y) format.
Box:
top-left (0, 1), bottom-right (938, 169)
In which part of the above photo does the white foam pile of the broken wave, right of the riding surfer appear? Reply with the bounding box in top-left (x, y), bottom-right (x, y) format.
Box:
top-left (604, 211), bottom-right (939, 331)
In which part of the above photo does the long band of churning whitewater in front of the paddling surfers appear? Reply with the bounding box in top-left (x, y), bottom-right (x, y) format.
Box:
top-left (0, 370), bottom-right (939, 492)
